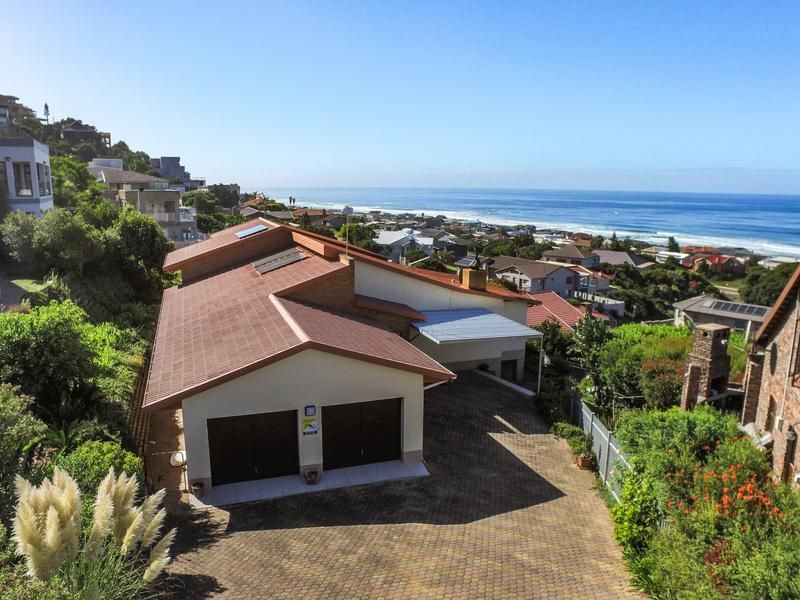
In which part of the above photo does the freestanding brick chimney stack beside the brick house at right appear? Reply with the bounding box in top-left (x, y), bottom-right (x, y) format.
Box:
top-left (681, 323), bottom-right (731, 410)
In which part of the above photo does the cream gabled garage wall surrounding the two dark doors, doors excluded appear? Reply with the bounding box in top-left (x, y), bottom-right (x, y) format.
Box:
top-left (182, 350), bottom-right (424, 489)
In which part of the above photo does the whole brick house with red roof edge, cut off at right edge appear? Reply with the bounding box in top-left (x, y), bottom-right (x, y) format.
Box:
top-left (741, 267), bottom-right (800, 483)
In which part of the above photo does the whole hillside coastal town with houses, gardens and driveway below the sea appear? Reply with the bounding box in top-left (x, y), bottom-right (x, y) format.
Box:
top-left (0, 68), bottom-right (800, 599)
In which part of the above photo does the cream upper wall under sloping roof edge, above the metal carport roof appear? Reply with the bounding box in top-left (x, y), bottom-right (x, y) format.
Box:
top-left (355, 260), bottom-right (527, 324)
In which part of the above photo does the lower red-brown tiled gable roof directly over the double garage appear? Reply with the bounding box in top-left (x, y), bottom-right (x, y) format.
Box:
top-left (143, 246), bottom-right (453, 410)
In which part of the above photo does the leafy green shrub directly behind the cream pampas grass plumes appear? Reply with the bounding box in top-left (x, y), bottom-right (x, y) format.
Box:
top-left (55, 441), bottom-right (143, 492)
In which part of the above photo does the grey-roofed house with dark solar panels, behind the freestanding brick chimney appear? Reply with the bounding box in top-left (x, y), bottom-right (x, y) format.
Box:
top-left (672, 295), bottom-right (769, 337)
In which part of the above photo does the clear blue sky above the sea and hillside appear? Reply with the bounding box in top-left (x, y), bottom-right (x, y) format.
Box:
top-left (6, 0), bottom-right (800, 193)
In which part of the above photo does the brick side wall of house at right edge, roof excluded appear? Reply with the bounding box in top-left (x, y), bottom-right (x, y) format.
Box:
top-left (756, 304), bottom-right (800, 477)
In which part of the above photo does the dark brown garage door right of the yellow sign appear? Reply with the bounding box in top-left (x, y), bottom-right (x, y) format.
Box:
top-left (322, 398), bottom-right (402, 469)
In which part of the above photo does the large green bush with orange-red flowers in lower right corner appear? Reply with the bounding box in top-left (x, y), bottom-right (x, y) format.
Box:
top-left (612, 406), bottom-right (800, 600)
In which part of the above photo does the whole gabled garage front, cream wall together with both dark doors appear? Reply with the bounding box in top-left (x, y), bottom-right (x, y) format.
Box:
top-left (181, 349), bottom-right (426, 491)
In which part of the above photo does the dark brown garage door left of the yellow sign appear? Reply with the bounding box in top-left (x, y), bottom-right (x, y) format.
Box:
top-left (207, 410), bottom-right (300, 485)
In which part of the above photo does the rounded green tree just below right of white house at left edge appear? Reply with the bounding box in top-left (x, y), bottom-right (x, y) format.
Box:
top-left (33, 208), bottom-right (102, 273)
